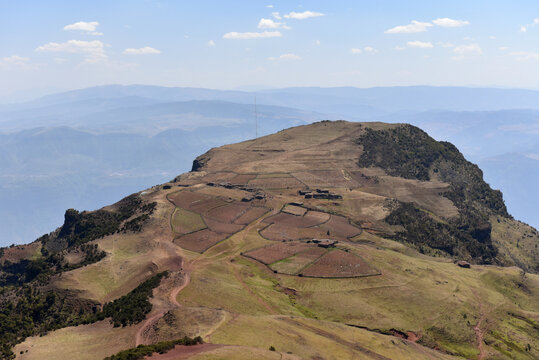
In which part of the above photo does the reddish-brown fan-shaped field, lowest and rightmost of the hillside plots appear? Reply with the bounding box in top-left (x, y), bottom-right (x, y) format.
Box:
top-left (301, 249), bottom-right (379, 277)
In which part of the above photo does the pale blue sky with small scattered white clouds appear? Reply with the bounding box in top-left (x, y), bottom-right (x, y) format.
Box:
top-left (0, 0), bottom-right (539, 97)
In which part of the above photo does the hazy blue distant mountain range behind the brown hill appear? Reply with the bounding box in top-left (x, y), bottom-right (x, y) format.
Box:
top-left (0, 85), bottom-right (539, 245)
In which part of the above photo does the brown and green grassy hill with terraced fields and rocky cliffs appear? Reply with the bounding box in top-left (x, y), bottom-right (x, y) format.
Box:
top-left (1, 121), bottom-right (539, 359)
